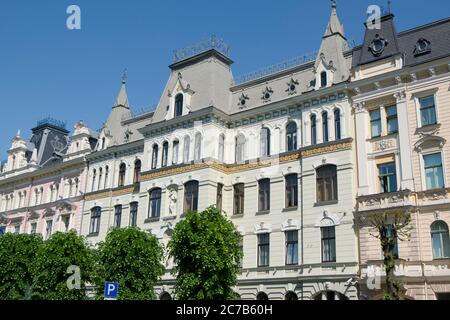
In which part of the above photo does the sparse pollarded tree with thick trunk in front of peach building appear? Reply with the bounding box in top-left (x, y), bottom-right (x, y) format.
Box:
top-left (370, 212), bottom-right (412, 300)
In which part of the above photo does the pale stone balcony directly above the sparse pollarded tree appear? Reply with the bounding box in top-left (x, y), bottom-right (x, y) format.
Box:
top-left (357, 190), bottom-right (414, 212)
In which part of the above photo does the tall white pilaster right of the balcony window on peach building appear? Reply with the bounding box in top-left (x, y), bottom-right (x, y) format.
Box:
top-left (394, 91), bottom-right (414, 190)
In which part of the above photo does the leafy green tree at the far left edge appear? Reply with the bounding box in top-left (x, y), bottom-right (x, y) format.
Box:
top-left (0, 233), bottom-right (42, 300)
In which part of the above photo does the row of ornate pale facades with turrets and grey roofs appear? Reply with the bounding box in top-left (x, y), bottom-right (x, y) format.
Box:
top-left (0, 2), bottom-right (450, 300)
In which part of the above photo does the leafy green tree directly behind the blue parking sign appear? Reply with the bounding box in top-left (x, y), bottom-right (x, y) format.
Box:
top-left (96, 228), bottom-right (164, 300)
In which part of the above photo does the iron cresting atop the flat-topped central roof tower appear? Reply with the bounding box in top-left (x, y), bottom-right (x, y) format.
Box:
top-left (173, 35), bottom-right (231, 63)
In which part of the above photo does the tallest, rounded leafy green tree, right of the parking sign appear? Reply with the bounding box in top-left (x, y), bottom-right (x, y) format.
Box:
top-left (168, 207), bottom-right (243, 300)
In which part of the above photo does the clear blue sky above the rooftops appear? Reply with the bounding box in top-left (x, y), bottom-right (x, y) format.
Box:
top-left (0, 0), bottom-right (450, 159)
